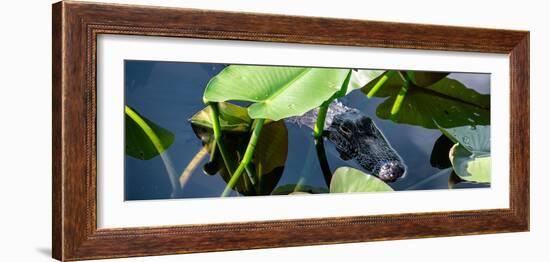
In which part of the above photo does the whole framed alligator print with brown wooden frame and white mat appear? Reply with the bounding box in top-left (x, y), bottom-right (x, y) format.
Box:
top-left (52, 1), bottom-right (529, 260)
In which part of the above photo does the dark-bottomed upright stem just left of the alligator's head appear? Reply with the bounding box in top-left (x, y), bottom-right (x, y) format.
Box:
top-left (313, 103), bottom-right (332, 185)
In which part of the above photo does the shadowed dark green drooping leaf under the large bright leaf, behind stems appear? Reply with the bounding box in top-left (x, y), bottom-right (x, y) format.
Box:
top-left (190, 103), bottom-right (288, 195)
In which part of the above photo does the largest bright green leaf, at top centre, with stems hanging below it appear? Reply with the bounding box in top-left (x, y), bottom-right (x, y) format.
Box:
top-left (203, 65), bottom-right (392, 196)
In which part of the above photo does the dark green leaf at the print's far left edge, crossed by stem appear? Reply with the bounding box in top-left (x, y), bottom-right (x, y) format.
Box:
top-left (124, 106), bottom-right (174, 160)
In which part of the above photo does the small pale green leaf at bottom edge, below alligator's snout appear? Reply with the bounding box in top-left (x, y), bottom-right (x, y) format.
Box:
top-left (330, 167), bottom-right (393, 193)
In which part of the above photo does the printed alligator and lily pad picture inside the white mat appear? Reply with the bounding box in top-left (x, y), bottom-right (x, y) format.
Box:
top-left (124, 60), bottom-right (491, 201)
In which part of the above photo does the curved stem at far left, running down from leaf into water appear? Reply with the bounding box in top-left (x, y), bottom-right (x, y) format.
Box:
top-left (124, 106), bottom-right (181, 197)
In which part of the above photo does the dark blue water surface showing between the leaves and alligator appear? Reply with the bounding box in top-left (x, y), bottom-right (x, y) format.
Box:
top-left (125, 61), bottom-right (490, 200)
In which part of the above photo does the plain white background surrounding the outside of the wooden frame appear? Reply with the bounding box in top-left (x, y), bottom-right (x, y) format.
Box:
top-left (0, 0), bottom-right (550, 262)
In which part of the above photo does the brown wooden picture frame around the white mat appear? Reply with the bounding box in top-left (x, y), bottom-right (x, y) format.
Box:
top-left (52, 1), bottom-right (529, 261)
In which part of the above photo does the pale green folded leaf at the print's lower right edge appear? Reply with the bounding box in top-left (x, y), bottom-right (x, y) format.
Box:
top-left (437, 123), bottom-right (491, 183)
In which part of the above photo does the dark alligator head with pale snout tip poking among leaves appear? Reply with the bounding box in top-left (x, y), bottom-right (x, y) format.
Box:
top-left (325, 109), bottom-right (406, 182)
